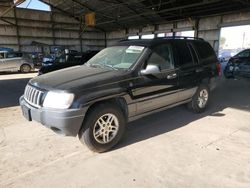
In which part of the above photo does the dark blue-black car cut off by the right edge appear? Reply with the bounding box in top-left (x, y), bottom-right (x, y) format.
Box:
top-left (224, 49), bottom-right (250, 78)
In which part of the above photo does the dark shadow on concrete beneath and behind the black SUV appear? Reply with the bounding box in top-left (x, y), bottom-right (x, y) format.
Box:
top-left (114, 80), bottom-right (250, 150)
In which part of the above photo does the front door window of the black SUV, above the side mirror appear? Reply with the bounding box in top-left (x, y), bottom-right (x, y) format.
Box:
top-left (147, 44), bottom-right (173, 70)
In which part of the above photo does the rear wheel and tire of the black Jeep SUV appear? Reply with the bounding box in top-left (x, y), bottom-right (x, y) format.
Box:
top-left (188, 85), bottom-right (210, 113)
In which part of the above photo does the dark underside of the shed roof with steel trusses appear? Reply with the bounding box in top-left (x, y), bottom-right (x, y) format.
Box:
top-left (40, 0), bottom-right (250, 31)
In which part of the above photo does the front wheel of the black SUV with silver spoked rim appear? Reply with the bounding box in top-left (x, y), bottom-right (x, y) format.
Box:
top-left (78, 103), bottom-right (126, 153)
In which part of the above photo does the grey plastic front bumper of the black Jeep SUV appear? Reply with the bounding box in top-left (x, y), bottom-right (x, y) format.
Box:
top-left (19, 96), bottom-right (87, 136)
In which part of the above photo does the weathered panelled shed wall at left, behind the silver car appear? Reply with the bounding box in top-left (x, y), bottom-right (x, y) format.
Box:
top-left (0, 7), bottom-right (105, 52)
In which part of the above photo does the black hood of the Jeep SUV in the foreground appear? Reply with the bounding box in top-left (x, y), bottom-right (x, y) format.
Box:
top-left (30, 65), bottom-right (125, 91)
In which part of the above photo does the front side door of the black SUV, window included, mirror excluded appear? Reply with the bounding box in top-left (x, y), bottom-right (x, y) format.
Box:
top-left (131, 43), bottom-right (178, 115)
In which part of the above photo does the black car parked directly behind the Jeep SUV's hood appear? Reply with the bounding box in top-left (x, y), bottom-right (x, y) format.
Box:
top-left (38, 51), bottom-right (99, 75)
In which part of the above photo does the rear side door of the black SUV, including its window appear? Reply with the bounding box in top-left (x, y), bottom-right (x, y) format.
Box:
top-left (174, 40), bottom-right (198, 101)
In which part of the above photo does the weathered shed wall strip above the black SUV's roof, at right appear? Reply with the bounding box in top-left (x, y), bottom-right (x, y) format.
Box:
top-left (107, 12), bottom-right (250, 52)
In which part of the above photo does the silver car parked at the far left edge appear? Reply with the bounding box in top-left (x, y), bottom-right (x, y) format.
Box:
top-left (0, 51), bottom-right (34, 73)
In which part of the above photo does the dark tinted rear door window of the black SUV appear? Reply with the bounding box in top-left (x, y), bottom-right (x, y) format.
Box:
top-left (175, 41), bottom-right (194, 66)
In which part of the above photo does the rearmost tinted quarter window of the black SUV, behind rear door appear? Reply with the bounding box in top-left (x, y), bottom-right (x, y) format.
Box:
top-left (193, 42), bottom-right (216, 61)
